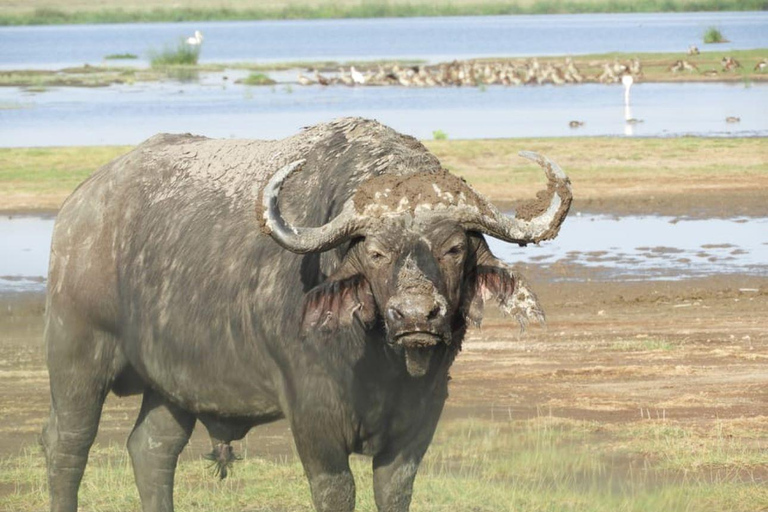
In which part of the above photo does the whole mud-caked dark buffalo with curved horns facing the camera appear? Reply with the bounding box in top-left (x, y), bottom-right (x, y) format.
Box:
top-left (42, 119), bottom-right (571, 512)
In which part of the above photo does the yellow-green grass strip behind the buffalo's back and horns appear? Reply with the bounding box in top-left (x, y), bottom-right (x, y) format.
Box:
top-left (0, 138), bottom-right (768, 210)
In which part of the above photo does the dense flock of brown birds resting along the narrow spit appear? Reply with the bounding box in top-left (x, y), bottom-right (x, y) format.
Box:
top-left (297, 58), bottom-right (642, 87)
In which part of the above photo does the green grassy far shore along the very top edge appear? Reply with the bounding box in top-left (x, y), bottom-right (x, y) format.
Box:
top-left (0, 0), bottom-right (768, 25)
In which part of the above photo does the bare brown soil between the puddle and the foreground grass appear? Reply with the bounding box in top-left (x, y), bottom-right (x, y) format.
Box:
top-left (0, 266), bottom-right (768, 457)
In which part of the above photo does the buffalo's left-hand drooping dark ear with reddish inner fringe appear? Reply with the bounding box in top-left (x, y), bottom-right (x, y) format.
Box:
top-left (302, 275), bottom-right (376, 333)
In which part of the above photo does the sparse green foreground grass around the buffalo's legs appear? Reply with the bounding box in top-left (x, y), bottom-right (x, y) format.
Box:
top-left (0, 416), bottom-right (768, 512)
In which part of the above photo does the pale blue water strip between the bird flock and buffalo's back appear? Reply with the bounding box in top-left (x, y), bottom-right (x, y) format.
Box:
top-left (0, 80), bottom-right (768, 147)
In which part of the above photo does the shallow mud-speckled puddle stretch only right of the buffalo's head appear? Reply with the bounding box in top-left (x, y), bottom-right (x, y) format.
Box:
top-left (489, 213), bottom-right (768, 281)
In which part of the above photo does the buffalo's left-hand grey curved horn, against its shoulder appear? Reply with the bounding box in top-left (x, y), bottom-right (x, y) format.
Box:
top-left (261, 160), bottom-right (364, 254)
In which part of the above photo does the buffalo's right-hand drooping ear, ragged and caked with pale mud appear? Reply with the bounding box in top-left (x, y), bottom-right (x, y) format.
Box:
top-left (467, 258), bottom-right (545, 331)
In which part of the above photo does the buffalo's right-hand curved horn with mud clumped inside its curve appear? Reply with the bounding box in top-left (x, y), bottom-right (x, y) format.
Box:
top-left (457, 151), bottom-right (573, 245)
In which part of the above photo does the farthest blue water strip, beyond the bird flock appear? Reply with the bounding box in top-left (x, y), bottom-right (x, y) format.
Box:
top-left (0, 12), bottom-right (768, 69)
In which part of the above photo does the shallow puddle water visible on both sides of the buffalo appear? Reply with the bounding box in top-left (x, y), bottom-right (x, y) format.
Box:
top-left (0, 213), bottom-right (768, 293)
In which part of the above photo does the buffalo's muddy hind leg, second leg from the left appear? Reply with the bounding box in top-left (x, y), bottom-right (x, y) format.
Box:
top-left (128, 390), bottom-right (195, 512)
